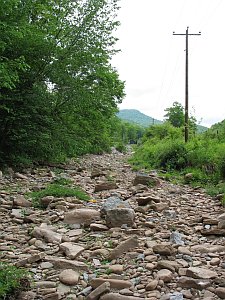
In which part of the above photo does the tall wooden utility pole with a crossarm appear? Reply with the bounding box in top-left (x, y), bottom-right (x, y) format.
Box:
top-left (173, 27), bottom-right (201, 143)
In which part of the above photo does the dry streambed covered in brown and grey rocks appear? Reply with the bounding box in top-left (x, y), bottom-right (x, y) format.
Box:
top-left (0, 148), bottom-right (225, 300)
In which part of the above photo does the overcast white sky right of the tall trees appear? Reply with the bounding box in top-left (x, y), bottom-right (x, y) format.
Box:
top-left (112, 0), bottom-right (225, 127)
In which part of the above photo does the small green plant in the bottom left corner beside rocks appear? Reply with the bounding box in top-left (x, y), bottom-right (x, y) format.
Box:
top-left (0, 262), bottom-right (30, 300)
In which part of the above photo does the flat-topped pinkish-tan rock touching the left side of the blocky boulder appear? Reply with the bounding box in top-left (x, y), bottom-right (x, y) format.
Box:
top-left (63, 208), bottom-right (100, 225)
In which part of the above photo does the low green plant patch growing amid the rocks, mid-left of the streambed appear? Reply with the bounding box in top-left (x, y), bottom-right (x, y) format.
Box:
top-left (28, 178), bottom-right (90, 208)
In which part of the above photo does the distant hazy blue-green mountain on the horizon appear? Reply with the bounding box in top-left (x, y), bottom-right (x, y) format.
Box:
top-left (117, 109), bottom-right (163, 127)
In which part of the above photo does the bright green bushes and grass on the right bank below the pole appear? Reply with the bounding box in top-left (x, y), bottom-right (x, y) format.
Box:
top-left (131, 103), bottom-right (225, 199)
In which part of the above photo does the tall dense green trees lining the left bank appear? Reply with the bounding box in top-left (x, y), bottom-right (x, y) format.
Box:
top-left (0, 0), bottom-right (124, 165)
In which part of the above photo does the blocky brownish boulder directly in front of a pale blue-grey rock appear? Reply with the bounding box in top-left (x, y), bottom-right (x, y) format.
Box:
top-left (106, 208), bottom-right (135, 228)
